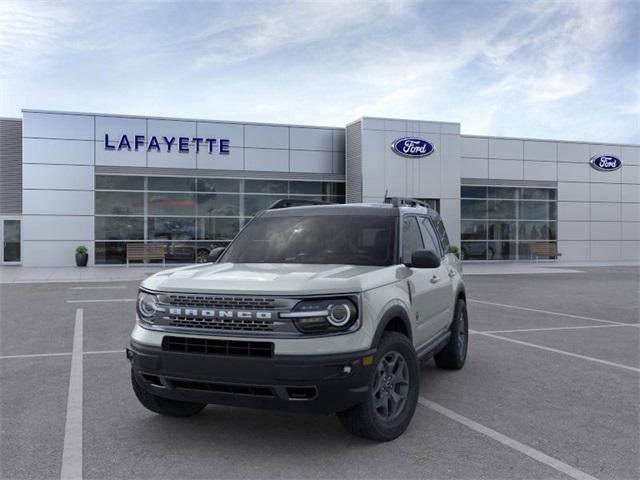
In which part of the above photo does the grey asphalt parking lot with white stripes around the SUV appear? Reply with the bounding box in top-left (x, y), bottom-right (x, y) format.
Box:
top-left (0, 267), bottom-right (640, 479)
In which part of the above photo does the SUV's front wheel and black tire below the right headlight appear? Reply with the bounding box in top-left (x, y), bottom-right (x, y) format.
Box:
top-left (338, 332), bottom-right (420, 442)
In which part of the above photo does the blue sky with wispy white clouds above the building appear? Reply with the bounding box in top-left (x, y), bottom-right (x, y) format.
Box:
top-left (0, 0), bottom-right (640, 143)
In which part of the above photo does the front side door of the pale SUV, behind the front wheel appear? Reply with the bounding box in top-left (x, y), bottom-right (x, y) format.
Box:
top-left (401, 215), bottom-right (442, 347)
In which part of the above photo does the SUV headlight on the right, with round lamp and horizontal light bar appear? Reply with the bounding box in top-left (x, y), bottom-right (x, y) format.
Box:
top-left (280, 298), bottom-right (358, 333)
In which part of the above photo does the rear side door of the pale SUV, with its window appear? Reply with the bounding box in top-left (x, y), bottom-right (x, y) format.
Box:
top-left (418, 217), bottom-right (455, 330)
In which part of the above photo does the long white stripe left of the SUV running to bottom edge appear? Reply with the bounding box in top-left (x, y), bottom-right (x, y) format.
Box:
top-left (60, 308), bottom-right (84, 480)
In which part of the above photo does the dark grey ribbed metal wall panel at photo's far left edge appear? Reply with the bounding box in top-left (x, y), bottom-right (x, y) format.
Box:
top-left (0, 118), bottom-right (22, 215)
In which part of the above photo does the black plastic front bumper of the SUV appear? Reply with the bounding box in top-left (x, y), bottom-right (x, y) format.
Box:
top-left (127, 342), bottom-right (375, 414)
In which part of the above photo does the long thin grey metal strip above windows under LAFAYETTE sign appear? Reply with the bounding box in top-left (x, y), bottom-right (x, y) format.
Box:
top-left (96, 165), bottom-right (345, 182)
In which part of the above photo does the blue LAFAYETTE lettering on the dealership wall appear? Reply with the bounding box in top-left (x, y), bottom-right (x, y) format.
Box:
top-left (104, 133), bottom-right (229, 155)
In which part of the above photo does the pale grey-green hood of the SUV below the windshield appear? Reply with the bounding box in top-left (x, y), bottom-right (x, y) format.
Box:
top-left (141, 263), bottom-right (398, 295)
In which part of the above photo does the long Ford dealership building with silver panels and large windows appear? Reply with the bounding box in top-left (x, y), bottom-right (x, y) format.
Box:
top-left (0, 110), bottom-right (640, 266)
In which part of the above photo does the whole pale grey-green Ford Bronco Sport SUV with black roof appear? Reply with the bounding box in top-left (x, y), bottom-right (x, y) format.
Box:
top-left (127, 198), bottom-right (468, 441)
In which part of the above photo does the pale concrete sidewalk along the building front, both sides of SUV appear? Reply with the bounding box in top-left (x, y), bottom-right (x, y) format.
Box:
top-left (0, 261), bottom-right (640, 284)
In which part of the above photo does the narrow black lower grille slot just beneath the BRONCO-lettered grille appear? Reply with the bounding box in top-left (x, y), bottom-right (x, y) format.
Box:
top-left (162, 337), bottom-right (273, 357)
